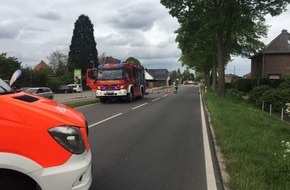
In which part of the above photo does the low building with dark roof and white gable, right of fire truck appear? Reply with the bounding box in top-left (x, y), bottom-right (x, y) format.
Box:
top-left (145, 69), bottom-right (170, 88)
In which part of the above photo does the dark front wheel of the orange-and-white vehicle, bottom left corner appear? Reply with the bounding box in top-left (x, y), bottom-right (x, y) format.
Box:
top-left (0, 171), bottom-right (40, 190)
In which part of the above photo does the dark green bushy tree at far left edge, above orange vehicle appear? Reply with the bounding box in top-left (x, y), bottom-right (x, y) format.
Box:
top-left (0, 53), bottom-right (21, 80)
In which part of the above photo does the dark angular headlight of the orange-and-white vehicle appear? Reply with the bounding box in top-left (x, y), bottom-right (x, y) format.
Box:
top-left (48, 126), bottom-right (86, 154)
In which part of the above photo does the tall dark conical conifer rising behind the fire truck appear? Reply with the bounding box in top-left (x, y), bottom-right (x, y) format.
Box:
top-left (68, 14), bottom-right (98, 75)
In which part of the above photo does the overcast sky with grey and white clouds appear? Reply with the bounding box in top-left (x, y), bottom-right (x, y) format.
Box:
top-left (0, 0), bottom-right (290, 76)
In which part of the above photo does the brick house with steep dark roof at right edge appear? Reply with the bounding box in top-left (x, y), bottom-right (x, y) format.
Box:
top-left (250, 30), bottom-right (290, 79)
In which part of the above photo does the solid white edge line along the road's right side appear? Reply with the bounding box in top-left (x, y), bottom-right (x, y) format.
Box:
top-left (199, 91), bottom-right (217, 190)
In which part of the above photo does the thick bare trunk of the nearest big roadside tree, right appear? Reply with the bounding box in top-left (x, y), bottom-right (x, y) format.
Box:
top-left (217, 32), bottom-right (226, 97)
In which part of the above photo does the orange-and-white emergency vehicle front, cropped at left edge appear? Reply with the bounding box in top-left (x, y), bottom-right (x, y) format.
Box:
top-left (0, 70), bottom-right (92, 190)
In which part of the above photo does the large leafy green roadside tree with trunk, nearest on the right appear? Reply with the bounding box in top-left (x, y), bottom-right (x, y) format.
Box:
top-left (161, 0), bottom-right (290, 96)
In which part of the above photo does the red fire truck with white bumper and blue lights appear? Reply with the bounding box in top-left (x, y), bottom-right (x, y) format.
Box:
top-left (87, 62), bottom-right (146, 103)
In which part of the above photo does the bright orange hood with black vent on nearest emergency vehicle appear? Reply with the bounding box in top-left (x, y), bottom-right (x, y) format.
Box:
top-left (0, 91), bottom-right (85, 128)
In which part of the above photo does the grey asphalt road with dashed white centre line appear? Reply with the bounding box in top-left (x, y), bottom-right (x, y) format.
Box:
top-left (69, 86), bottom-right (223, 190)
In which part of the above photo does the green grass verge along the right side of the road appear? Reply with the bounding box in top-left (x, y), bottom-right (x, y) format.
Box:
top-left (204, 91), bottom-right (290, 190)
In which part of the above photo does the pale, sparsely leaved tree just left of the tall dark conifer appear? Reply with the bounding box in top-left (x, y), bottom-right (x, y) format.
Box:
top-left (47, 50), bottom-right (68, 76)
